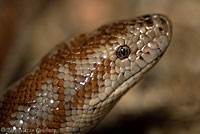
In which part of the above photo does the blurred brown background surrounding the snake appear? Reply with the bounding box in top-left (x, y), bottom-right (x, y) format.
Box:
top-left (0, 0), bottom-right (200, 134)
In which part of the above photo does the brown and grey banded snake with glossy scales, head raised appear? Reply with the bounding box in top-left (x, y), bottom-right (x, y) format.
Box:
top-left (0, 14), bottom-right (172, 134)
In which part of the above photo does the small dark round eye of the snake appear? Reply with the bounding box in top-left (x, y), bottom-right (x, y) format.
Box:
top-left (116, 45), bottom-right (130, 60)
